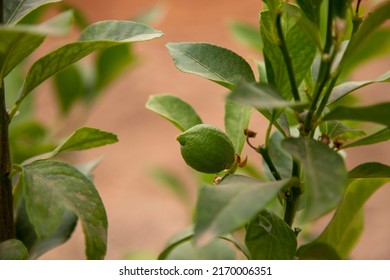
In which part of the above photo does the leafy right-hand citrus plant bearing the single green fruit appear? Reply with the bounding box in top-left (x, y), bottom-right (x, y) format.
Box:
top-left (146, 0), bottom-right (390, 259)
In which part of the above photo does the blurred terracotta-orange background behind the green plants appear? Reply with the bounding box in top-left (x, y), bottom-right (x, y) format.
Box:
top-left (32, 0), bottom-right (390, 259)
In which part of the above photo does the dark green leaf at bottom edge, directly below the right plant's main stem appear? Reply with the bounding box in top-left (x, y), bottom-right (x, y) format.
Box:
top-left (245, 210), bottom-right (297, 260)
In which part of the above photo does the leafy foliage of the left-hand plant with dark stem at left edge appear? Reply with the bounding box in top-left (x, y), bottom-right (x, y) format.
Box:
top-left (0, 0), bottom-right (162, 259)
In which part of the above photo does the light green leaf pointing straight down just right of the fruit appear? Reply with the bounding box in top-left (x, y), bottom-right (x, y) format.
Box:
top-left (225, 98), bottom-right (252, 154)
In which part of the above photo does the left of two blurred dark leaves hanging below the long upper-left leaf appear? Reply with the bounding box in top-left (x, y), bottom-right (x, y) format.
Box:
top-left (53, 64), bottom-right (87, 114)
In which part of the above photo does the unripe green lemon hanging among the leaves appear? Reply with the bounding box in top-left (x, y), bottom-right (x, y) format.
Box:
top-left (177, 124), bottom-right (235, 173)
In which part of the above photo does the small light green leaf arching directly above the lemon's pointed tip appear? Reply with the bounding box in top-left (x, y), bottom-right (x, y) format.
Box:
top-left (146, 94), bottom-right (202, 131)
